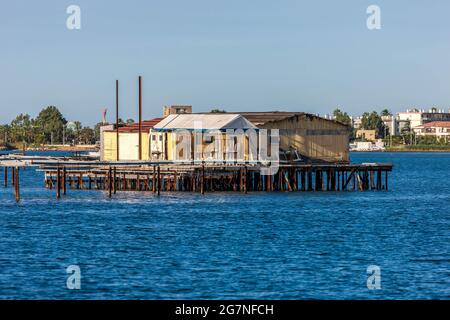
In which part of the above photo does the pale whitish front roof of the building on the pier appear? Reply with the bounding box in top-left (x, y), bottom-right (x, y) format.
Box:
top-left (154, 113), bottom-right (256, 130)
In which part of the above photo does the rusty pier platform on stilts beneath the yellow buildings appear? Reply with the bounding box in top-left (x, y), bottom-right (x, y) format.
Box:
top-left (0, 157), bottom-right (392, 202)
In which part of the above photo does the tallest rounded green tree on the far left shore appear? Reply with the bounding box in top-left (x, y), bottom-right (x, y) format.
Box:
top-left (36, 106), bottom-right (67, 143)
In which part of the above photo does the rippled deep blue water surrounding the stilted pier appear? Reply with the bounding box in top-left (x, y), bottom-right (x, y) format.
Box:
top-left (0, 153), bottom-right (450, 299)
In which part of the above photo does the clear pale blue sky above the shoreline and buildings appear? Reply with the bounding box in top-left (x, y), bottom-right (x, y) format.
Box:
top-left (0, 0), bottom-right (450, 125)
